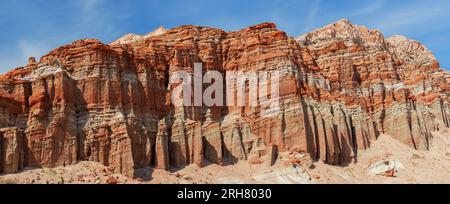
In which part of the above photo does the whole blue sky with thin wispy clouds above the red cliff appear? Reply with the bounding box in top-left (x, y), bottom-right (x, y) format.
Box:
top-left (0, 0), bottom-right (450, 73)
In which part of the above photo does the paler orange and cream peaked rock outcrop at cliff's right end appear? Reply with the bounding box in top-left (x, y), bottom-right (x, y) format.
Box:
top-left (298, 20), bottom-right (448, 156)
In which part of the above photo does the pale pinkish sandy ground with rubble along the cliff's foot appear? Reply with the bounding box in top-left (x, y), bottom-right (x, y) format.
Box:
top-left (0, 129), bottom-right (450, 184)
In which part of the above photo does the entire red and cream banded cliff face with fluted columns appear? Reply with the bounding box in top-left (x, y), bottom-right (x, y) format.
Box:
top-left (0, 20), bottom-right (450, 176)
